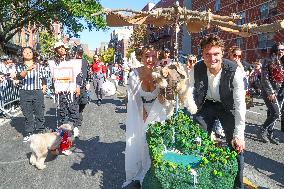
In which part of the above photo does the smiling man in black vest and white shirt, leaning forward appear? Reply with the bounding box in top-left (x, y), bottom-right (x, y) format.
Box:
top-left (188, 35), bottom-right (246, 189)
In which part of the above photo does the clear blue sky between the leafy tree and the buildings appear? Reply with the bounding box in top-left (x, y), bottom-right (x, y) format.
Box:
top-left (76, 0), bottom-right (158, 50)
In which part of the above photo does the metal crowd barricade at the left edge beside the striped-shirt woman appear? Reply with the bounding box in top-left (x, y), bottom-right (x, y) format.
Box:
top-left (0, 80), bottom-right (20, 117)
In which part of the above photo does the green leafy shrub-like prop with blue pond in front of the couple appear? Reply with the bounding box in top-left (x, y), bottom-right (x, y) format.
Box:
top-left (143, 111), bottom-right (238, 189)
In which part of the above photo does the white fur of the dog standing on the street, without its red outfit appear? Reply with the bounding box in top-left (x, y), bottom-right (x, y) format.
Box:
top-left (29, 124), bottom-right (75, 169)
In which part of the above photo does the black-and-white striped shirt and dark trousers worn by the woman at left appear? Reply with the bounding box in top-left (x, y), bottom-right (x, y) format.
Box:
top-left (16, 63), bottom-right (46, 135)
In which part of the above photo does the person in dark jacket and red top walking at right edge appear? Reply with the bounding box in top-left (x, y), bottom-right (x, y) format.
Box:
top-left (260, 42), bottom-right (284, 144)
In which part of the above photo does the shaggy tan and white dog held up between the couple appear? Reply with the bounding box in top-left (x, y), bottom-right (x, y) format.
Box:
top-left (152, 62), bottom-right (197, 116)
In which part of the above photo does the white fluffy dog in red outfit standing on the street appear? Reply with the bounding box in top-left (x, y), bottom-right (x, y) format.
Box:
top-left (30, 124), bottom-right (76, 169)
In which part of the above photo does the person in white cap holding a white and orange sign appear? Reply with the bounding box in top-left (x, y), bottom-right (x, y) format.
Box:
top-left (49, 42), bottom-right (82, 132)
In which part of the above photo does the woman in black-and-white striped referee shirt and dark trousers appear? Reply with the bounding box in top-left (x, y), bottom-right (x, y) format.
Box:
top-left (16, 47), bottom-right (46, 142)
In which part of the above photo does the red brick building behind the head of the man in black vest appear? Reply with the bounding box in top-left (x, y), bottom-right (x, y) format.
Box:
top-left (191, 0), bottom-right (284, 62)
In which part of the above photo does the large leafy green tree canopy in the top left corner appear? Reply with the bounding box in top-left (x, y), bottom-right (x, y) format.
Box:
top-left (0, 0), bottom-right (106, 47)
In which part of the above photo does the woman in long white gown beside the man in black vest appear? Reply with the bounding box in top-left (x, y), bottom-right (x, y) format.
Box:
top-left (123, 47), bottom-right (166, 187)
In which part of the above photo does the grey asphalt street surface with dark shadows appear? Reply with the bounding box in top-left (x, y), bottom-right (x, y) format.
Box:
top-left (0, 88), bottom-right (284, 189)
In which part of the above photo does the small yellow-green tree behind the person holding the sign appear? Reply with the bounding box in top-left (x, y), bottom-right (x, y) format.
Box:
top-left (39, 31), bottom-right (56, 58)
